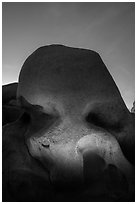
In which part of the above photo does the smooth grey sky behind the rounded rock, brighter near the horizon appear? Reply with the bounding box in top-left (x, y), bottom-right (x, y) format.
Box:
top-left (2, 2), bottom-right (135, 108)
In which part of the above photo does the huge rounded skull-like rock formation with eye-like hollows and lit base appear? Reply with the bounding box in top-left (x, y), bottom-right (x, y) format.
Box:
top-left (3, 45), bottom-right (134, 201)
